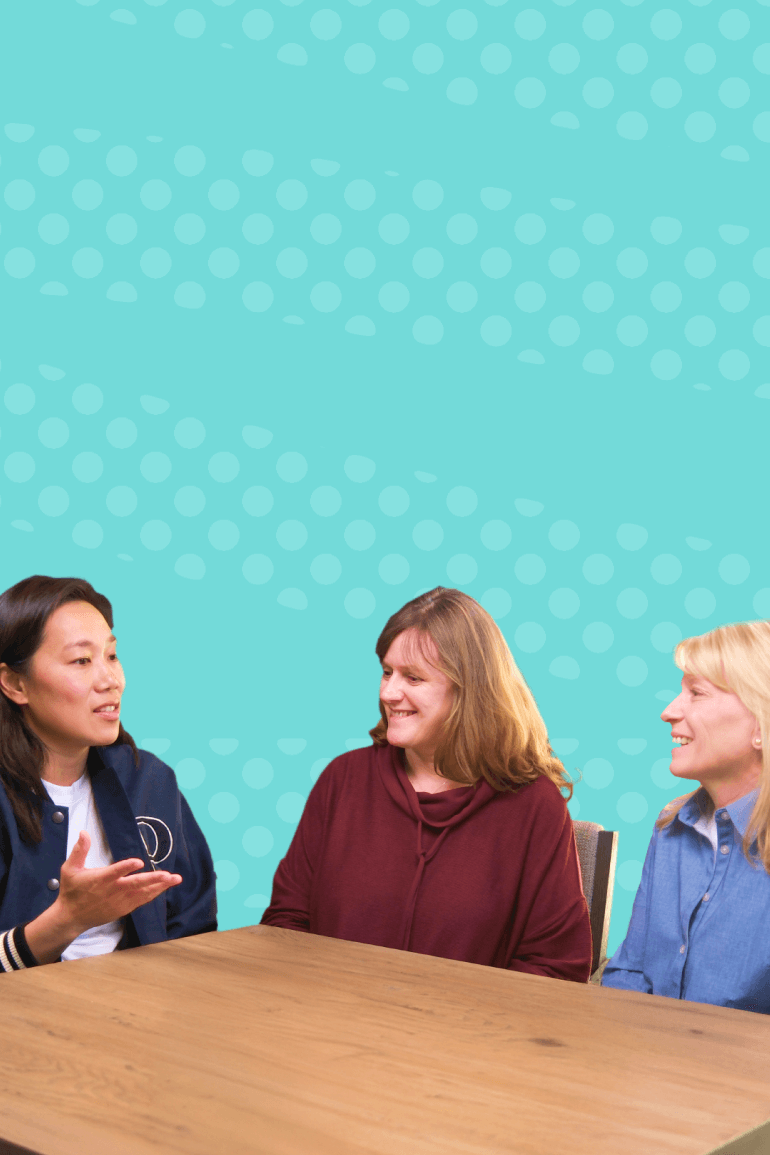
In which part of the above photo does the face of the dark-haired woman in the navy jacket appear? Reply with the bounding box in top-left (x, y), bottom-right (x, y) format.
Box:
top-left (3, 602), bottom-right (126, 754)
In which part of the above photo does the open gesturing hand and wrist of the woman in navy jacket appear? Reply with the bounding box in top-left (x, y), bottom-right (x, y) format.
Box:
top-left (24, 830), bottom-right (181, 962)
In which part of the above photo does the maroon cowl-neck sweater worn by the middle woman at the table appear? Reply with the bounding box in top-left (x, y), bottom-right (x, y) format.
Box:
top-left (262, 746), bottom-right (591, 983)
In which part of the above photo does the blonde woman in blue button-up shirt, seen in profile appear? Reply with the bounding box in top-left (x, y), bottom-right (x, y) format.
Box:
top-left (601, 621), bottom-right (770, 1014)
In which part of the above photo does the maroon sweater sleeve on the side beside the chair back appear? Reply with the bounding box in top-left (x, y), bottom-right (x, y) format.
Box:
top-left (508, 780), bottom-right (591, 983)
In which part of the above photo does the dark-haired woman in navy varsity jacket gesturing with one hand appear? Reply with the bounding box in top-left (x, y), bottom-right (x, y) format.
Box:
top-left (0, 576), bottom-right (217, 971)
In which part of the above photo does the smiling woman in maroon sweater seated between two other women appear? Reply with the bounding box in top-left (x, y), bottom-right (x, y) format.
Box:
top-left (262, 588), bottom-right (591, 982)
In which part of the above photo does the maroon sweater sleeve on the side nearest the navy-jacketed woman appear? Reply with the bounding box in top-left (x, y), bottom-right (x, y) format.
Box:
top-left (260, 767), bottom-right (329, 931)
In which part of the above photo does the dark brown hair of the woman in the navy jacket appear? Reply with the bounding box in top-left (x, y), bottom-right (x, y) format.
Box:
top-left (0, 574), bottom-right (139, 843)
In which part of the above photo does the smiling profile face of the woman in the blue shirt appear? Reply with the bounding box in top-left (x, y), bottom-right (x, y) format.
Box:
top-left (660, 673), bottom-right (762, 805)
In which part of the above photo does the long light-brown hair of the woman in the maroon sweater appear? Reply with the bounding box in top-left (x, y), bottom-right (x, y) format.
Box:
top-left (369, 586), bottom-right (573, 798)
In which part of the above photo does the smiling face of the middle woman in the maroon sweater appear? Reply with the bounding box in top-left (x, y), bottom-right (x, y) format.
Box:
top-left (380, 629), bottom-right (455, 763)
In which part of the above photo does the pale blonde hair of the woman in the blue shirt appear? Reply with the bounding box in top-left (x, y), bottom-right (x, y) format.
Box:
top-left (656, 621), bottom-right (770, 873)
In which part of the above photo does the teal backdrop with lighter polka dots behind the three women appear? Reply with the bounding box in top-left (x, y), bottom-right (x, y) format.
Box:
top-left (0, 0), bottom-right (770, 948)
